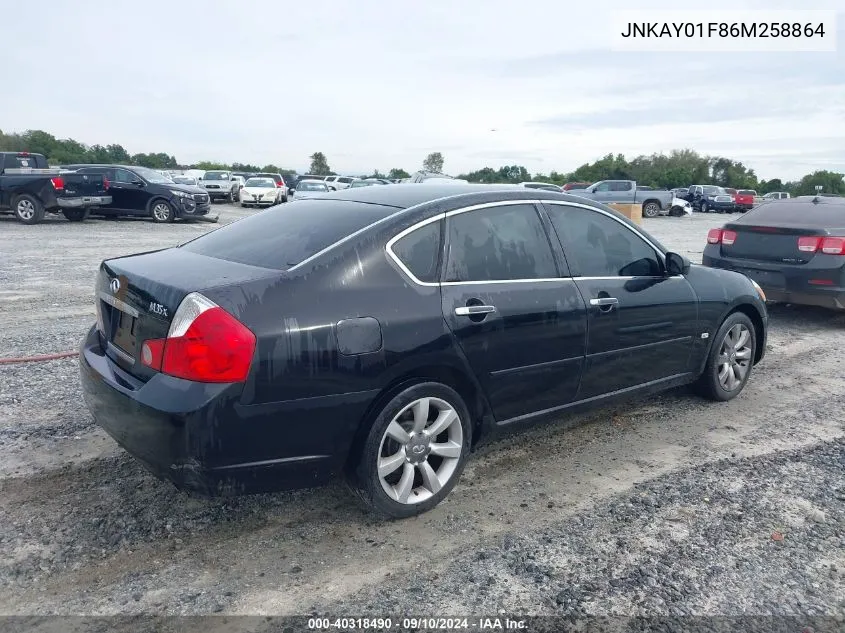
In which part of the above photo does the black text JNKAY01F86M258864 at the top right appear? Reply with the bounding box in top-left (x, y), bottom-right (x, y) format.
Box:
top-left (619, 22), bottom-right (825, 38)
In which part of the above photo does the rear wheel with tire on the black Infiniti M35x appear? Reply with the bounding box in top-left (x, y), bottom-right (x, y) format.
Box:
top-left (353, 382), bottom-right (472, 519)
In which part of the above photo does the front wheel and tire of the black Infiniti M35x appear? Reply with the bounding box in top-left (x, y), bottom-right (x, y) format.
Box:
top-left (695, 312), bottom-right (757, 402)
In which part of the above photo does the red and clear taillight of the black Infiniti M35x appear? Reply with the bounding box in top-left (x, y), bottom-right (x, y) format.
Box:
top-left (141, 292), bottom-right (255, 382)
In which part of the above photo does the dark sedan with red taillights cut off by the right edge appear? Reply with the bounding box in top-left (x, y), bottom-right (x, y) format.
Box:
top-left (702, 196), bottom-right (845, 310)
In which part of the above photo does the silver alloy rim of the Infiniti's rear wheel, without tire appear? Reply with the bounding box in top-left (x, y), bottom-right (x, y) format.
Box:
top-left (377, 398), bottom-right (464, 505)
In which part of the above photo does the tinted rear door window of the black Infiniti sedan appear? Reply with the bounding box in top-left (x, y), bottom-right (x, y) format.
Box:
top-left (445, 204), bottom-right (558, 281)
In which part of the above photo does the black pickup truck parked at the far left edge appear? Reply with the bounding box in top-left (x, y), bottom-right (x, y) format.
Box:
top-left (0, 152), bottom-right (111, 224)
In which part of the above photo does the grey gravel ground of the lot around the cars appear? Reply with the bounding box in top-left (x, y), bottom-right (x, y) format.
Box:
top-left (0, 205), bottom-right (845, 630)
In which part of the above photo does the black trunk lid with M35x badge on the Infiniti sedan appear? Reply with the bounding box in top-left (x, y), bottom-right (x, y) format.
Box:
top-left (95, 248), bottom-right (280, 380)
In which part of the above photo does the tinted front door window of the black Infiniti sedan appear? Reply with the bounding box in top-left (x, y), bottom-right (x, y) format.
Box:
top-left (548, 205), bottom-right (663, 277)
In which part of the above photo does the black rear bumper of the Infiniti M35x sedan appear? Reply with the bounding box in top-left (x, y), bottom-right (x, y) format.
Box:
top-left (79, 327), bottom-right (366, 496)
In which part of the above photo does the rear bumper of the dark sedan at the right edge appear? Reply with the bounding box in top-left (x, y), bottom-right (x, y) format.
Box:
top-left (701, 252), bottom-right (845, 310)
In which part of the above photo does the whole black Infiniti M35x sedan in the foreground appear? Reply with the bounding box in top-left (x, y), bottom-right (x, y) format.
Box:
top-left (80, 184), bottom-right (767, 517)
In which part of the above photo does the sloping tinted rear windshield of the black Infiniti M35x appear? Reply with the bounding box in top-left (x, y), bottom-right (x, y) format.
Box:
top-left (181, 200), bottom-right (398, 270)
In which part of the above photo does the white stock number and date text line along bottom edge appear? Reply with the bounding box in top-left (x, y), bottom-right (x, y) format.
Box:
top-left (308, 617), bottom-right (527, 631)
